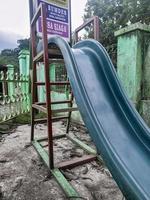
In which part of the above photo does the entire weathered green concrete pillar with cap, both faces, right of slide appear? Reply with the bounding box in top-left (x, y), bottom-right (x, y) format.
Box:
top-left (115, 23), bottom-right (150, 125)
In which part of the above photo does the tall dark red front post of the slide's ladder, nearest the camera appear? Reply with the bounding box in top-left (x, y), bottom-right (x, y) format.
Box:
top-left (41, 4), bottom-right (54, 169)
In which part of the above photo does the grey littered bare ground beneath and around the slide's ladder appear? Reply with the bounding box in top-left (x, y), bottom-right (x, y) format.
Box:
top-left (0, 122), bottom-right (123, 200)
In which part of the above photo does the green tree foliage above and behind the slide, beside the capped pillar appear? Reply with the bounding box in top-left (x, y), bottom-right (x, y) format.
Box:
top-left (84, 0), bottom-right (150, 46)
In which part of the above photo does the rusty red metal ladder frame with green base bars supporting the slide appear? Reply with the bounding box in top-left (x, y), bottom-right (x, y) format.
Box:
top-left (29, 0), bottom-right (101, 198)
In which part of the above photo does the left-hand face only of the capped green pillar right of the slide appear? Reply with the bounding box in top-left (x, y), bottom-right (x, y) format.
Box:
top-left (115, 23), bottom-right (143, 107)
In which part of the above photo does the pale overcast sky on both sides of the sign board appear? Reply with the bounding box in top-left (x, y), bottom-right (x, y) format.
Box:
top-left (0, 0), bottom-right (87, 50)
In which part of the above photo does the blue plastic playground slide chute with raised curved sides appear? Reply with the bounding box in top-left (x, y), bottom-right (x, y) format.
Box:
top-left (39, 37), bottom-right (150, 200)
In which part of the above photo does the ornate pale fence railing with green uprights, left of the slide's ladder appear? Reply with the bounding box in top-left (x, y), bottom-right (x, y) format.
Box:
top-left (0, 71), bottom-right (30, 123)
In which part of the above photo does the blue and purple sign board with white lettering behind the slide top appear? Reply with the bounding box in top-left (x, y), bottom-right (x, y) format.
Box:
top-left (37, 0), bottom-right (71, 41)
